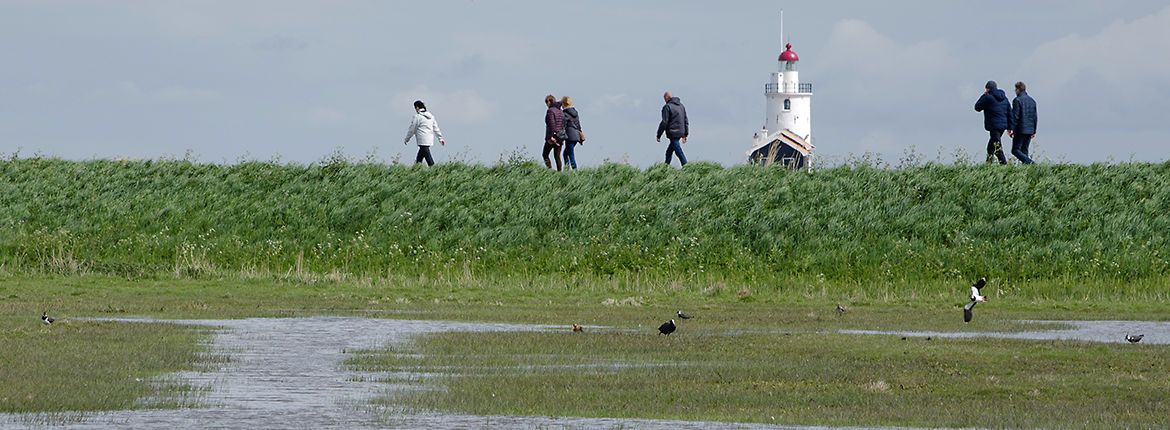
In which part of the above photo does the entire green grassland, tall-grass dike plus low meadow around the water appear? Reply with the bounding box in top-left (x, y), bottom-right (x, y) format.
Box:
top-left (0, 158), bottom-right (1170, 428)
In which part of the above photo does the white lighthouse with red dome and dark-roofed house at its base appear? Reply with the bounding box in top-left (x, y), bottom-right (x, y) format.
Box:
top-left (746, 43), bottom-right (814, 168)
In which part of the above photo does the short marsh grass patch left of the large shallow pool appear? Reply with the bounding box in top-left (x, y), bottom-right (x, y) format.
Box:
top-left (0, 313), bottom-right (211, 412)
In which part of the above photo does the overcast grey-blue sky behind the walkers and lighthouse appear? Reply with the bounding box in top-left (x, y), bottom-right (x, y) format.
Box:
top-left (0, 0), bottom-right (1170, 166)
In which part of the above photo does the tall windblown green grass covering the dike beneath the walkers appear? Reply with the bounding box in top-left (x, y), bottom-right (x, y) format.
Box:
top-left (0, 157), bottom-right (1170, 287)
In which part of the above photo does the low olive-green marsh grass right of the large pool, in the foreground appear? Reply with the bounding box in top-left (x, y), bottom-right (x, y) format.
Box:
top-left (351, 317), bottom-right (1170, 429)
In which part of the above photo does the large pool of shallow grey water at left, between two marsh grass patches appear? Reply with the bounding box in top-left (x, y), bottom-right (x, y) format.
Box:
top-left (0, 317), bottom-right (542, 429)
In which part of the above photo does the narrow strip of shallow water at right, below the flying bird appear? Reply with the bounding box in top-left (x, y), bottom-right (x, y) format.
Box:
top-left (838, 321), bottom-right (1170, 345)
